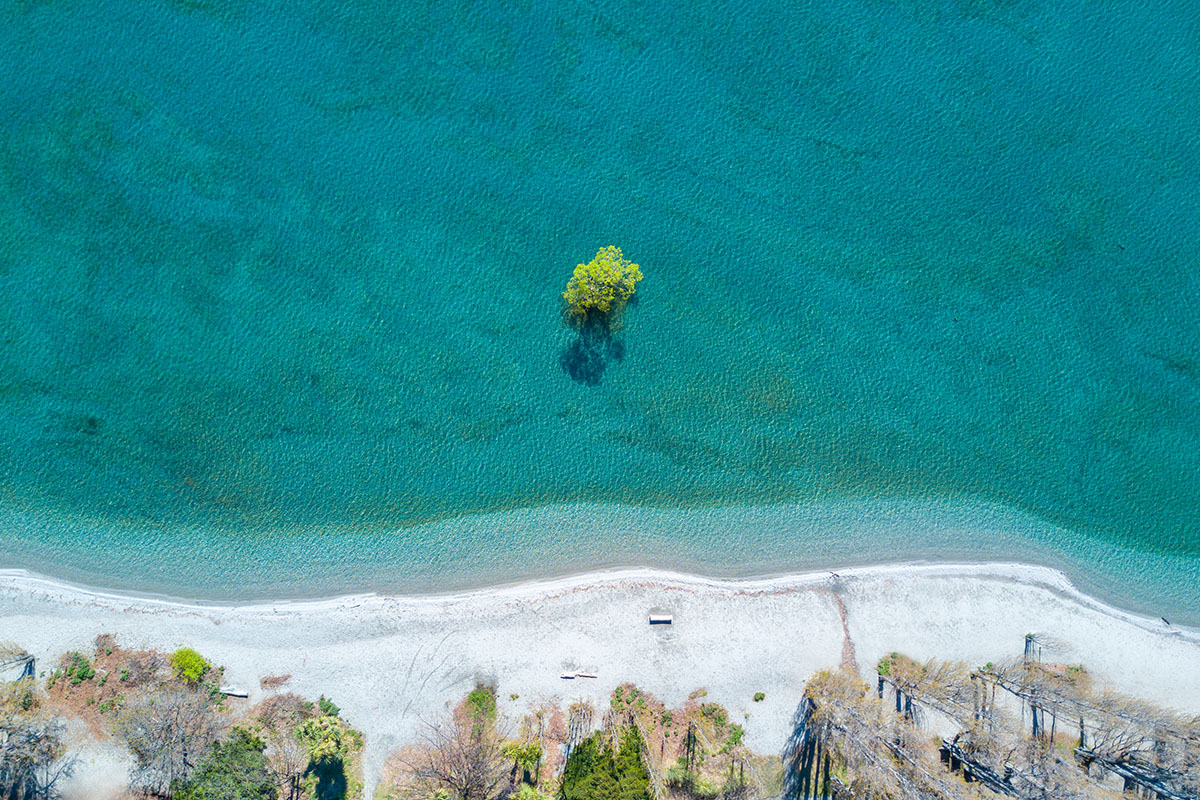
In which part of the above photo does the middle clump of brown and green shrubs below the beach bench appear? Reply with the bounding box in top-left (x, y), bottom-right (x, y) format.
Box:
top-left (376, 684), bottom-right (780, 800)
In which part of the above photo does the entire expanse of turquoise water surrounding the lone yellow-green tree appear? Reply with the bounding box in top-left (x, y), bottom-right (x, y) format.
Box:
top-left (0, 0), bottom-right (1200, 620)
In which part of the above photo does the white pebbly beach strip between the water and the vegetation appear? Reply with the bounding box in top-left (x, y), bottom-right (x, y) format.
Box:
top-left (0, 565), bottom-right (1200, 790)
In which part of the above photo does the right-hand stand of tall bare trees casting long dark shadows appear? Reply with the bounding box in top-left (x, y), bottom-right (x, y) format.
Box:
top-left (785, 637), bottom-right (1200, 800)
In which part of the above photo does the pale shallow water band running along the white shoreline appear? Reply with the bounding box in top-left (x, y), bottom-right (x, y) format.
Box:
top-left (0, 501), bottom-right (1200, 628)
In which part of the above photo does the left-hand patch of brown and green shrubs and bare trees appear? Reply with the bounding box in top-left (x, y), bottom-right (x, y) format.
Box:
top-left (0, 636), bottom-right (362, 800)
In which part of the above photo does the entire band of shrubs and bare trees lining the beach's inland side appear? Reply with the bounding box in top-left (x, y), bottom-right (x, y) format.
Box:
top-left (0, 636), bottom-right (1200, 800)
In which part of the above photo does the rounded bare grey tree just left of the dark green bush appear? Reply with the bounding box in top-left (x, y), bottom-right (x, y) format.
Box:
top-left (116, 687), bottom-right (223, 796)
